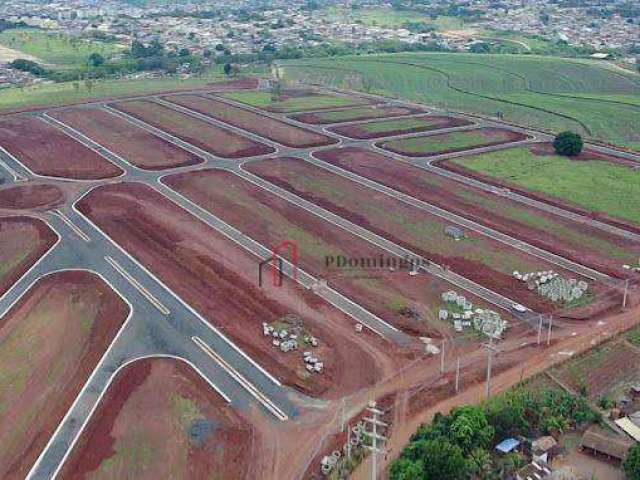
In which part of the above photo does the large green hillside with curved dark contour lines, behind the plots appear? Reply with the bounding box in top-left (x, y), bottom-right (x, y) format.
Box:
top-left (284, 53), bottom-right (640, 150)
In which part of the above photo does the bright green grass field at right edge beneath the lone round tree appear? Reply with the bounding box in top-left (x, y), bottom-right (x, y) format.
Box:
top-left (453, 147), bottom-right (640, 224)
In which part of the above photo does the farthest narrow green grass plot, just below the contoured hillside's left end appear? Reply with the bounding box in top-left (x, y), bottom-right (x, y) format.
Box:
top-left (222, 91), bottom-right (371, 113)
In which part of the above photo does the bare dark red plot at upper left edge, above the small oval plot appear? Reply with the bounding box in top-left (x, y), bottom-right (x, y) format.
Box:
top-left (0, 116), bottom-right (123, 180)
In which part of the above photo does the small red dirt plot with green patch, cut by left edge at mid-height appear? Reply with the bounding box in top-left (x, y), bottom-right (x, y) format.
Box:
top-left (0, 217), bottom-right (58, 295)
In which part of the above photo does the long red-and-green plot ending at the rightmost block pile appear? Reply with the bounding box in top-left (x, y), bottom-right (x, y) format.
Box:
top-left (245, 158), bottom-right (564, 310)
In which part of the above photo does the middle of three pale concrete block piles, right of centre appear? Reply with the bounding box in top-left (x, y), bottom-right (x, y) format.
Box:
top-left (438, 290), bottom-right (509, 338)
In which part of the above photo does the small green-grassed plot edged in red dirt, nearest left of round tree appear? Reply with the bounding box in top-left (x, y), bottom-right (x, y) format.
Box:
top-left (378, 127), bottom-right (527, 157)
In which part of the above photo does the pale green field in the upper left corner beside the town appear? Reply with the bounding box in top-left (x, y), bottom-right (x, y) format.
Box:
top-left (0, 29), bottom-right (125, 67)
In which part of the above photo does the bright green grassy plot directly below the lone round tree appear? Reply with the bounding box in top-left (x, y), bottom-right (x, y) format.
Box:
top-left (442, 145), bottom-right (640, 231)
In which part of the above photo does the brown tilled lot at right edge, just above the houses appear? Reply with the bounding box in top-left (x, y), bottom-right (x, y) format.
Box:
top-left (551, 340), bottom-right (640, 400)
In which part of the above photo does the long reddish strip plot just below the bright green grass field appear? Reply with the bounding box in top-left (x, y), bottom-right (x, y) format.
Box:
top-left (314, 147), bottom-right (640, 277)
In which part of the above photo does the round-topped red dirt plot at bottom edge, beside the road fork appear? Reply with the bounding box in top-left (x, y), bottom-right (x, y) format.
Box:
top-left (60, 358), bottom-right (260, 480)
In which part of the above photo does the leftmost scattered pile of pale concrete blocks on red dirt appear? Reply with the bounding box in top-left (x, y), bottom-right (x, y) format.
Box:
top-left (262, 315), bottom-right (324, 373)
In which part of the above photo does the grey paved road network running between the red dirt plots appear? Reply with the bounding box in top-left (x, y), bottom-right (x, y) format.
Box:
top-left (0, 84), bottom-right (629, 479)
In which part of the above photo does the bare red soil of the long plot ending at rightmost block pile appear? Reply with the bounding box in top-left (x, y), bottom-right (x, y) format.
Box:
top-left (245, 158), bottom-right (564, 311)
